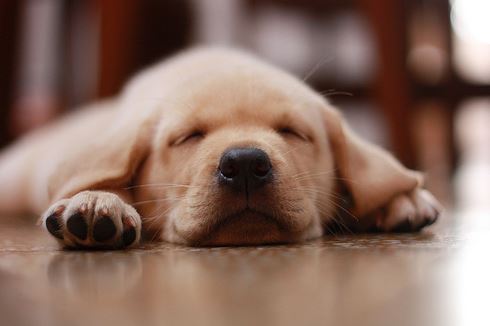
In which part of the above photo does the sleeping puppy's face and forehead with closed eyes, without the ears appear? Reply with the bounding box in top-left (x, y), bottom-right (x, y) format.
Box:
top-left (137, 69), bottom-right (335, 245)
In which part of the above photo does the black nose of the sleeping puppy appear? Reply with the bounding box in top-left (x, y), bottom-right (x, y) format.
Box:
top-left (218, 148), bottom-right (272, 193)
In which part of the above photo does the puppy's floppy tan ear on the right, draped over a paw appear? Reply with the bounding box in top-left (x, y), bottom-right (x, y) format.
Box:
top-left (325, 107), bottom-right (423, 217)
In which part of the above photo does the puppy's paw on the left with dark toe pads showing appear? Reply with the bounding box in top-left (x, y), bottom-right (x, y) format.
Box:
top-left (42, 191), bottom-right (141, 249)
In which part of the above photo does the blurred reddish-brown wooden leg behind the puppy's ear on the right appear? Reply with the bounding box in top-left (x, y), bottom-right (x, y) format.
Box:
top-left (358, 0), bottom-right (416, 167)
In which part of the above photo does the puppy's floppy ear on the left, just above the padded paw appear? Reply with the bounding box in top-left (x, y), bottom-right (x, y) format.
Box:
top-left (48, 101), bottom-right (153, 202)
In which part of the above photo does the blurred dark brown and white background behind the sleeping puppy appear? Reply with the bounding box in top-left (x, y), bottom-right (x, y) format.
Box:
top-left (0, 0), bottom-right (490, 208)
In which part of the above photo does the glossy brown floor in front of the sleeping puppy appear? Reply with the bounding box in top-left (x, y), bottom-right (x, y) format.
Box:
top-left (0, 212), bottom-right (490, 326)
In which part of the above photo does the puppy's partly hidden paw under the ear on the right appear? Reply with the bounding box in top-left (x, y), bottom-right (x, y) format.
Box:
top-left (376, 189), bottom-right (442, 232)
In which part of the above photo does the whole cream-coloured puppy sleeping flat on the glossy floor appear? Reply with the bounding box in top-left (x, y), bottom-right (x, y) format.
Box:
top-left (0, 49), bottom-right (440, 248)
